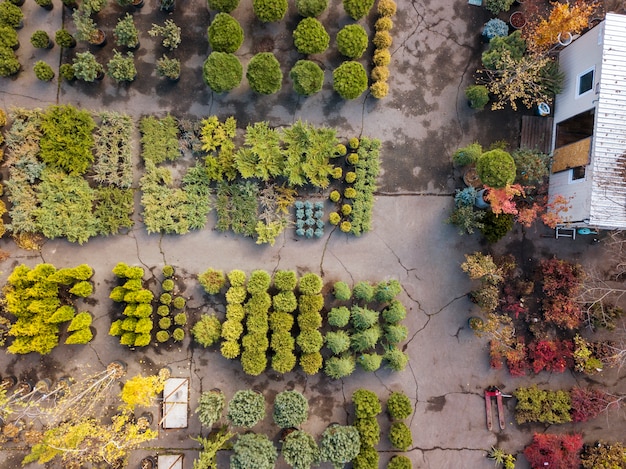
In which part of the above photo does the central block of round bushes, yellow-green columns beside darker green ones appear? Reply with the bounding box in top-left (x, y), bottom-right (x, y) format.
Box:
top-left (192, 269), bottom-right (408, 379)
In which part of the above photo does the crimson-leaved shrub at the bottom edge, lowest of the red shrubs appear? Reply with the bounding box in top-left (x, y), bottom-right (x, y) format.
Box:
top-left (524, 433), bottom-right (583, 469)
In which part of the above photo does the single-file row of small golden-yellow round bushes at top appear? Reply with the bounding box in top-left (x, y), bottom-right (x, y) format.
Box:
top-left (370, 0), bottom-right (397, 99)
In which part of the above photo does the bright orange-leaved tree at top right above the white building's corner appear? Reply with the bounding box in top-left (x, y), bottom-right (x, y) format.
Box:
top-left (524, 0), bottom-right (596, 52)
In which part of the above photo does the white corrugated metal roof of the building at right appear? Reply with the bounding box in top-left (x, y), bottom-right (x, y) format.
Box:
top-left (589, 13), bottom-right (626, 229)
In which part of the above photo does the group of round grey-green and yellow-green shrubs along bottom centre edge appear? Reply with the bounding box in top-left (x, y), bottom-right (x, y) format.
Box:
top-left (196, 389), bottom-right (412, 469)
